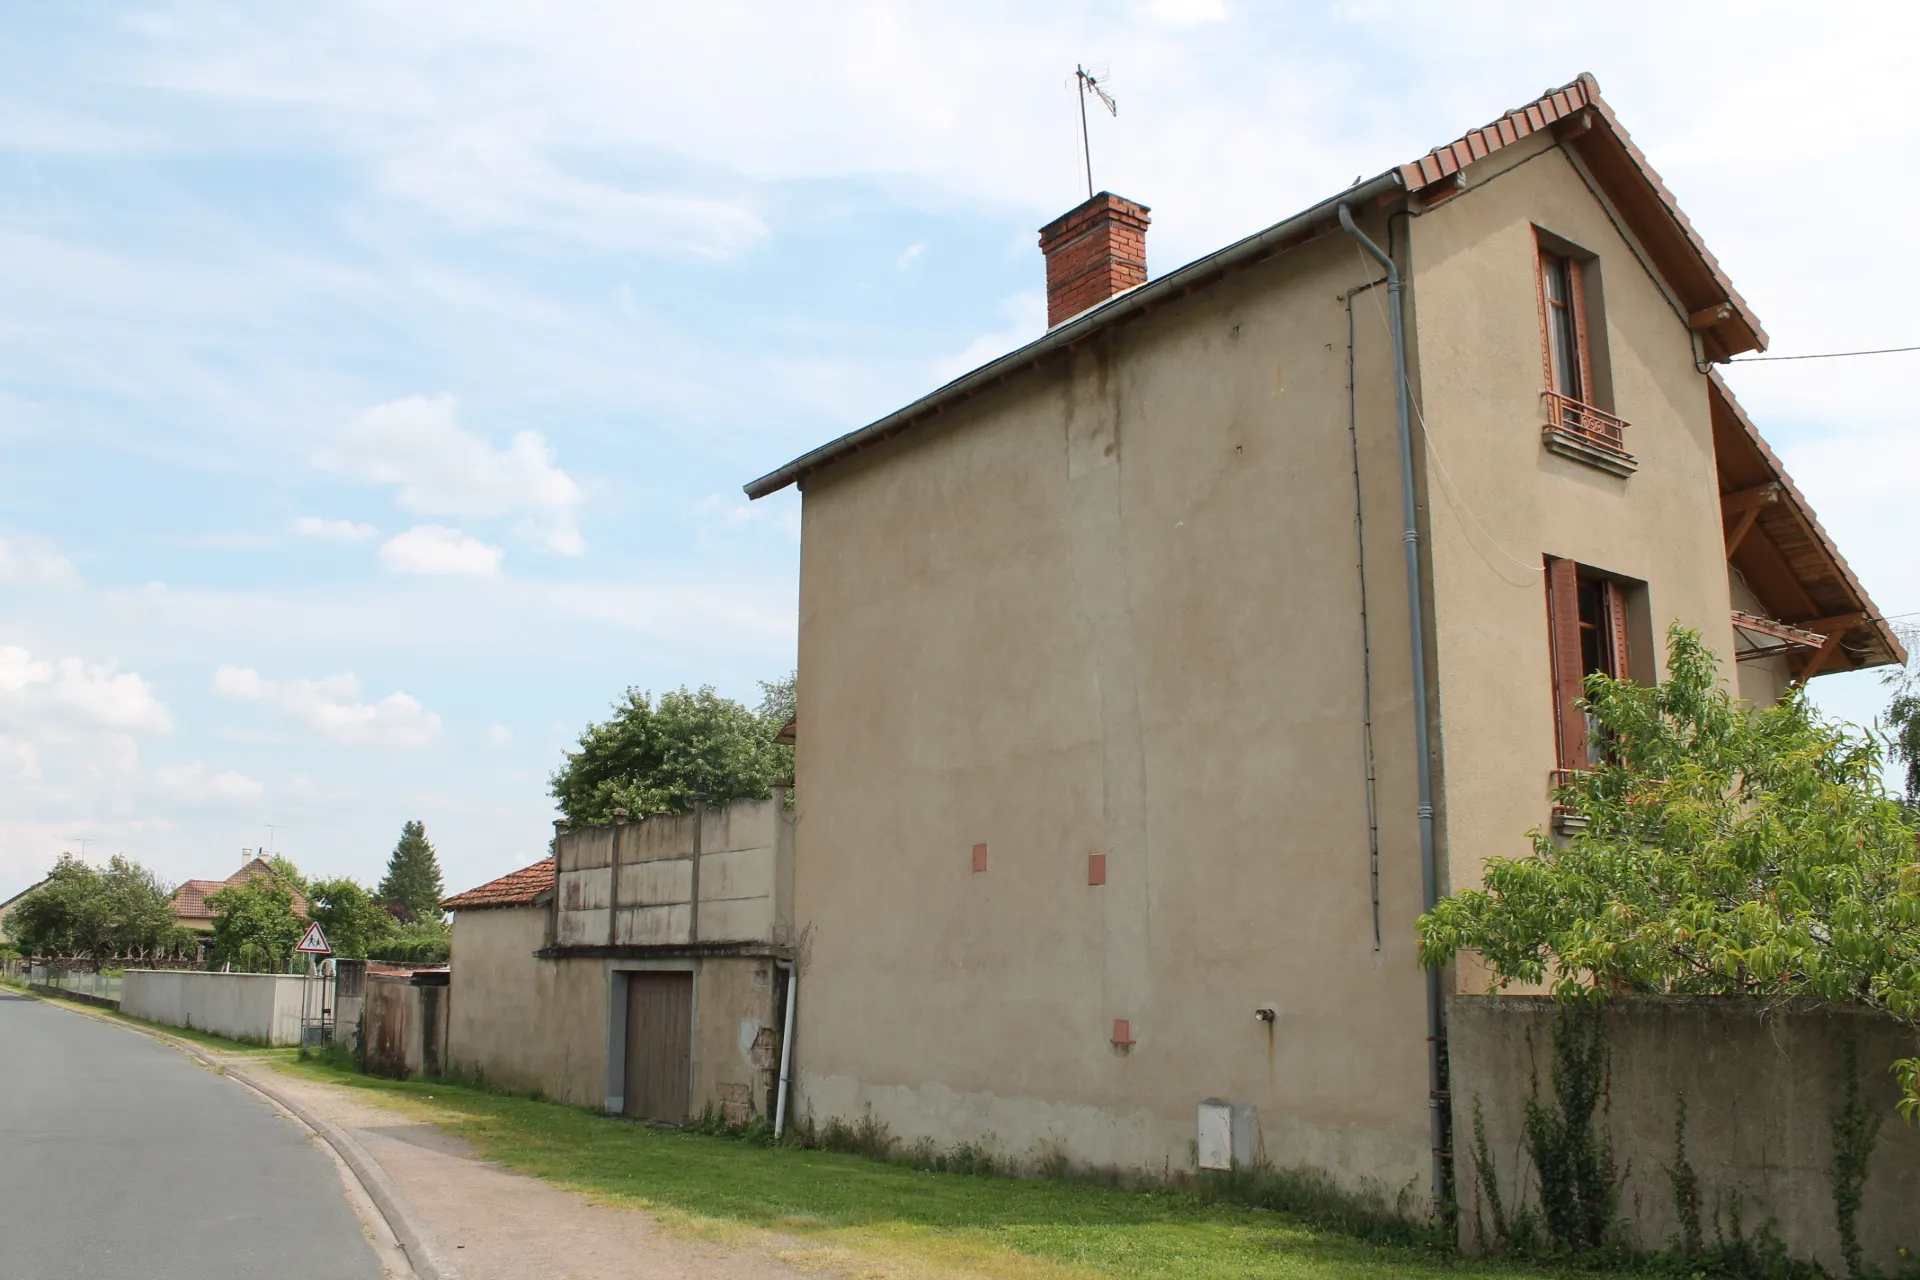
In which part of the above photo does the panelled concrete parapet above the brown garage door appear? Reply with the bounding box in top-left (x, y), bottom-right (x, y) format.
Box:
top-left (555, 793), bottom-right (793, 946)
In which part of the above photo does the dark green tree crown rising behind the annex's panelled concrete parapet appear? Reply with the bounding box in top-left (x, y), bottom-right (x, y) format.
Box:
top-left (553, 677), bottom-right (793, 823)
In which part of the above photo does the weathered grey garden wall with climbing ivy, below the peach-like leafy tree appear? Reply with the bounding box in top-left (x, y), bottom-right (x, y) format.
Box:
top-left (1448, 996), bottom-right (1920, 1274)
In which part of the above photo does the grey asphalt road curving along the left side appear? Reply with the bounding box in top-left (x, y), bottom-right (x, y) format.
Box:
top-left (0, 992), bottom-right (382, 1280)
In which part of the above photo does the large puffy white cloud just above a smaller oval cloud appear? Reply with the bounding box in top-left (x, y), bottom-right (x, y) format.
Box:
top-left (319, 395), bottom-right (586, 555)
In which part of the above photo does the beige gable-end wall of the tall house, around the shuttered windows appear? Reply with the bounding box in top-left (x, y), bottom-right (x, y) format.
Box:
top-left (1405, 134), bottom-right (1776, 940)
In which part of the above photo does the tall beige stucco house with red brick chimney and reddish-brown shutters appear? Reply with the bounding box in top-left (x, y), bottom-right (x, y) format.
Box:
top-left (747, 77), bottom-right (1903, 1220)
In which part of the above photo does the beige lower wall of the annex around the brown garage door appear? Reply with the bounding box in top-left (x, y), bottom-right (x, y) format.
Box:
top-left (447, 901), bottom-right (780, 1123)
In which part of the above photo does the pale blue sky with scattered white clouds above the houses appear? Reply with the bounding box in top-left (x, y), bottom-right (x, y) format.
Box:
top-left (0, 0), bottom-right (1920, 898)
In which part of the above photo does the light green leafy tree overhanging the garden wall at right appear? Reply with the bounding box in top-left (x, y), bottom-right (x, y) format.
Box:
top-left (1419, 626), bottom-right (1920, 1119)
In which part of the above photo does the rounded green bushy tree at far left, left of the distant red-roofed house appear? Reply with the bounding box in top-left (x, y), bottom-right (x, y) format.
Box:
top-left (8, 854), bottom-right (192, 961)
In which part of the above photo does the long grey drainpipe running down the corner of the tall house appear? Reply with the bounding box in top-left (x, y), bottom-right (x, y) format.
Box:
top-left (1340, 205), bottom-right (1450, 1217)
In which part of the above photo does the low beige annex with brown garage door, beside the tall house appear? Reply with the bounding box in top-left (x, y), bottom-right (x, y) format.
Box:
top-left (442, 783), bottom-right (795, 1125)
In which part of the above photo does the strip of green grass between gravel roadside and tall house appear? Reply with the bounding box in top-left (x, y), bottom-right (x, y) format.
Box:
top-left (278, 1061), bottom-right (1582, 1280)
